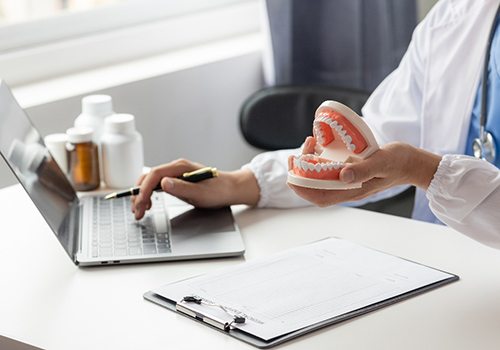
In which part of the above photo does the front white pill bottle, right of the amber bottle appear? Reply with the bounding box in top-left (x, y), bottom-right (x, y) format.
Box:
top-left (101, 113), bottom-right (144, 188)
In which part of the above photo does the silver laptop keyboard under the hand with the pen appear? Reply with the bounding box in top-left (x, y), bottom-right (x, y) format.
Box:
top-left (91, 196), bottom-right (171, 258)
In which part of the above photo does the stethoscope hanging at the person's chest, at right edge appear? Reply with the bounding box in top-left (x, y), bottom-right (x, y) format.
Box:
top-left (472, 6), bottom-right (500, 163)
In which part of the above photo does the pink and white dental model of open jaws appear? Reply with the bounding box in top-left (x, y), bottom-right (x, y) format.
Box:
top-left (288, 101), bottom-right (379, 190)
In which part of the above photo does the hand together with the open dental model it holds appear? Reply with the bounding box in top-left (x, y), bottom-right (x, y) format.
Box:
top-left (288, 101), bottom-right (441, 207)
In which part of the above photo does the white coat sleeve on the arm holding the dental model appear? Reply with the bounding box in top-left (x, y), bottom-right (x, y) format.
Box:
top-left (427, 155), bottom-right (500, 248)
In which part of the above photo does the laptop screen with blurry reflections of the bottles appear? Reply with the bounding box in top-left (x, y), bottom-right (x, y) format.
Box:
top-left (0, 80), bottom-right (78, 257)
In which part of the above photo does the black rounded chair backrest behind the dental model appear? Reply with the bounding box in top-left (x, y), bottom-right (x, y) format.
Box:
top-left (240, 85), bottom-right (369, 150)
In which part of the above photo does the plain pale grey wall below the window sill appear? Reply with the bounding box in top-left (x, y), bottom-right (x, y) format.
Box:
top-left (0, 51), bottom-right (262, 187)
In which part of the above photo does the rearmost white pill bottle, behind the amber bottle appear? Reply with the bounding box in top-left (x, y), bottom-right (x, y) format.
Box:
top-left (75, 95), bottom-right (113, 145)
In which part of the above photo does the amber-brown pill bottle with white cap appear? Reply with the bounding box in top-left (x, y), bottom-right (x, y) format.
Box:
top-left (66, 127), bottom-right (100, 191)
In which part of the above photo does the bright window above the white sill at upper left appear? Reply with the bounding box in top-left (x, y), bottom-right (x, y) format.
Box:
top-left (0, 0), bottom-right (259, 85)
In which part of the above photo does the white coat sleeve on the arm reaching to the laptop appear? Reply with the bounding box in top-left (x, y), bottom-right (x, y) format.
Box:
top-left (242, 149), bottom-right (312, 208)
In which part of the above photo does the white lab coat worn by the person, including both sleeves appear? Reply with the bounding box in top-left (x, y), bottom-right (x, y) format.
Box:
top-left (244, 0), bottom-right (500, 248)
